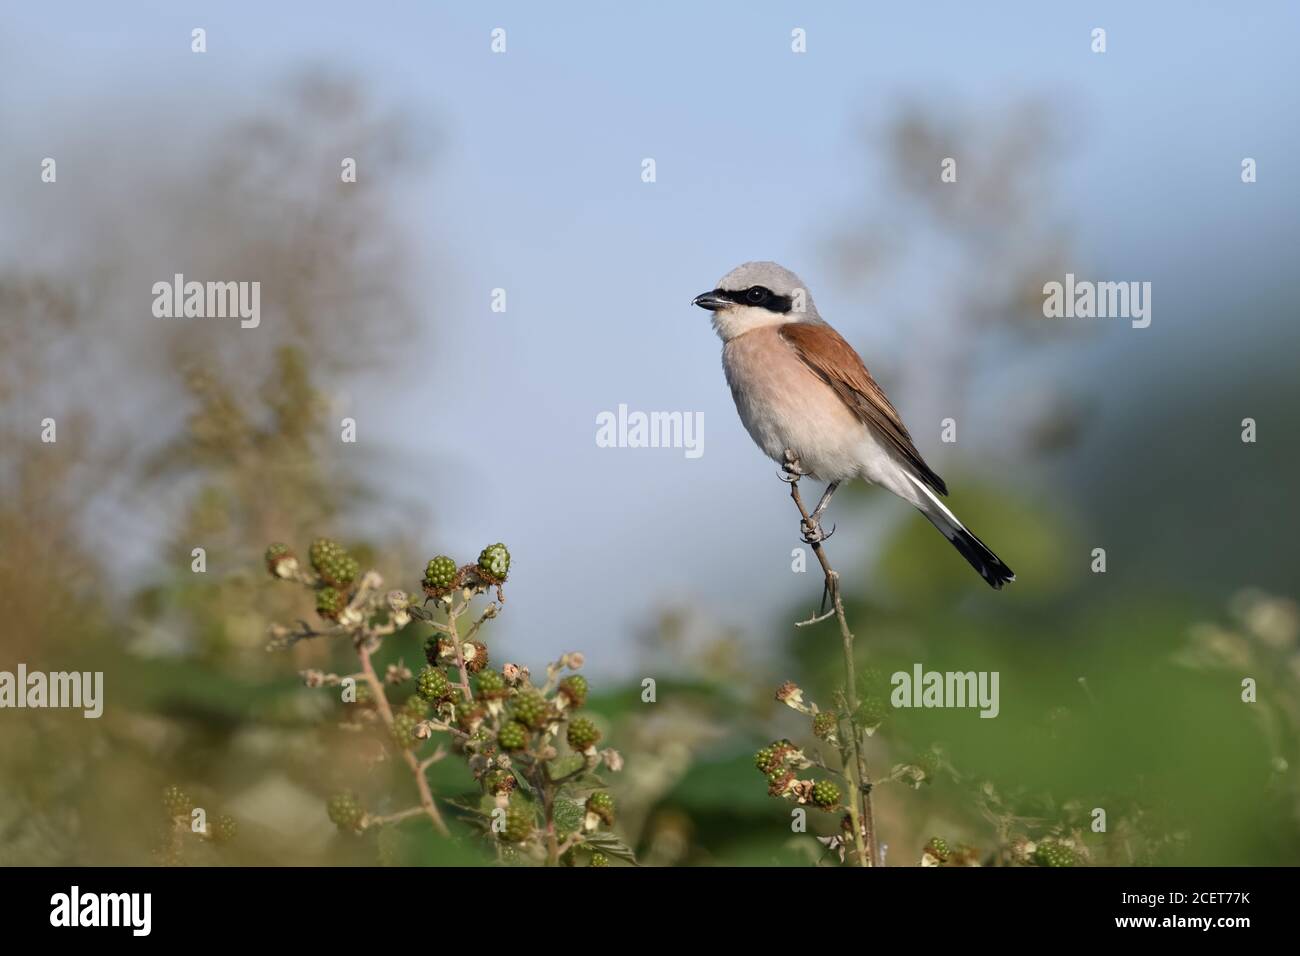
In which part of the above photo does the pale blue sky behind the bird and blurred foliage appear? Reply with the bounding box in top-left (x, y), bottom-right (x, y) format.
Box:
top-left (0, 3), bottom-right (1300, 666)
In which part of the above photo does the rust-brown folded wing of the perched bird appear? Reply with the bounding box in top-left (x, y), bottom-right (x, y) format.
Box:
top-left (779, 323), bottom-right (948, 494)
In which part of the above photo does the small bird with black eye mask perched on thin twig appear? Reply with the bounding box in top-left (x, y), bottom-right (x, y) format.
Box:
top-left (692, 261), bottom-right (1015, 589)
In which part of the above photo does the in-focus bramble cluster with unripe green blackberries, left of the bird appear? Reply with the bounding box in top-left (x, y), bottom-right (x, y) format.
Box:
top-left (262, 537), bottom-right (632, 866)
